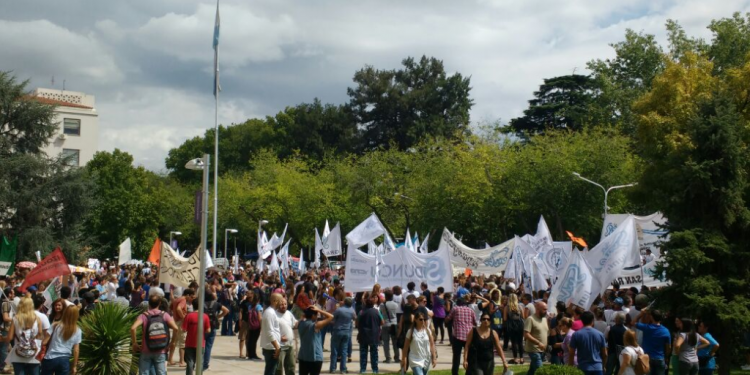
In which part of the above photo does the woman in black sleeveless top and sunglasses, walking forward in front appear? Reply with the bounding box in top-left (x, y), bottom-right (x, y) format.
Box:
top-left (464, 313), bottom-right (508, 375)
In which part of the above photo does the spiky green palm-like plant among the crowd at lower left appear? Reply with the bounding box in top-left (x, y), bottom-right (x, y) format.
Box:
top-left (78, 303), bottom-right (138, 375)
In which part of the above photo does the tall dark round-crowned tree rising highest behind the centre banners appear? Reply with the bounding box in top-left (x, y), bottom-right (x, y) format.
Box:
top-left (347, 56), bottom-right (473, 150)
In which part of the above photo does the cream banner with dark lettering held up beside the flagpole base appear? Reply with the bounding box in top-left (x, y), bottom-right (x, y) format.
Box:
top-left (159, 242), bottom-right (207, 288)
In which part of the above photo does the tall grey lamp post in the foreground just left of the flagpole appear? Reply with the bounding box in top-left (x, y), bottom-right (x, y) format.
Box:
top-left (185, 154), bottom-right (210, 375)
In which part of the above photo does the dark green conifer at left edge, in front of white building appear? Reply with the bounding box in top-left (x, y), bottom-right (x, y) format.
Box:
top-left (0, 72), bottom-right (93, 262)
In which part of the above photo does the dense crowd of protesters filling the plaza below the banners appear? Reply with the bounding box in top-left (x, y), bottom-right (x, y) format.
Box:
top-left (0, 264), bottom-right (750, 375)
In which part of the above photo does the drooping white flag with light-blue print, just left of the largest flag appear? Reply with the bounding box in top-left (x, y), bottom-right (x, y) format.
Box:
top-left (548, 251), bottom-right (596, 310)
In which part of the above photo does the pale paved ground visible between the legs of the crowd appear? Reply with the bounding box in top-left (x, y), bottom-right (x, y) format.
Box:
top-left (168, 331), bottom-right (528, 374)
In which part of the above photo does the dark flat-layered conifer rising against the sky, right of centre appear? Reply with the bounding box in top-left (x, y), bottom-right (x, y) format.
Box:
top-left (509, 74), bottom-right (599, 134)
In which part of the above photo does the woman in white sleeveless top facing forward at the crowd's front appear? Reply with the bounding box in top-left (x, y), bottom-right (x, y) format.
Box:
top-left (401, 312), bottom-right (437, 375)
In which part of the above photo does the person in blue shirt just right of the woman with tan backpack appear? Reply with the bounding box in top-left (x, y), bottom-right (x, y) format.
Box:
top-left (635, 309), bottom-right (671, 375)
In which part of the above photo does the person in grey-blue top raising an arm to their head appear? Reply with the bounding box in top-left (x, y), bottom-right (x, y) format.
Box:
top-left (299, 306), bottom-right (334, 375)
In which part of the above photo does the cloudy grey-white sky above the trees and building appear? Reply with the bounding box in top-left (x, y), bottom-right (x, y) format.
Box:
top-left (0, 0), bottom-right (750, 171)
